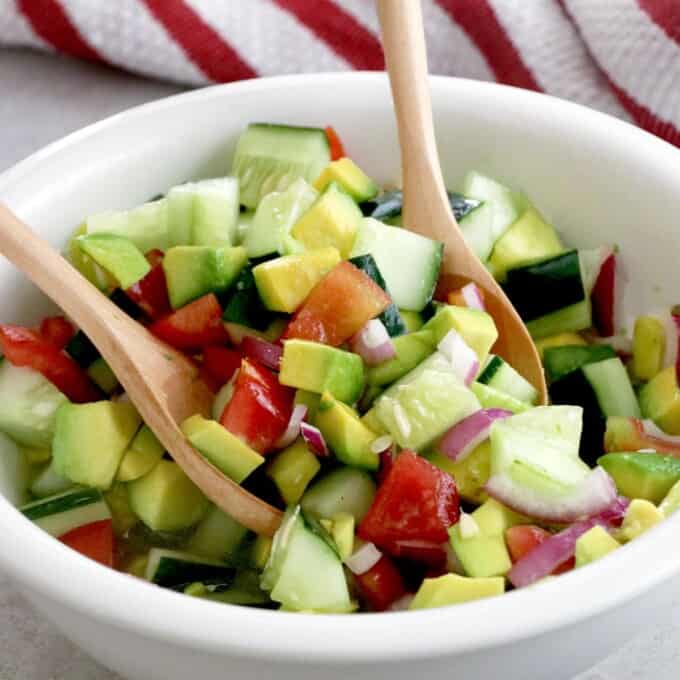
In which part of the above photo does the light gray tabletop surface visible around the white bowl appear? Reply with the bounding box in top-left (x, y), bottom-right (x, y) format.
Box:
top-left (0, 49), bottom-right (680, 680)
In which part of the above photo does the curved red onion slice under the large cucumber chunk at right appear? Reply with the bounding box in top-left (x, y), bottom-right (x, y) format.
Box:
top-left (484, 467), bottom-right (616, 524)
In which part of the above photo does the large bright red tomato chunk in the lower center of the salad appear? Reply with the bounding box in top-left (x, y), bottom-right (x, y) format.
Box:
top-left (358, 451), bottom-right (460, 554)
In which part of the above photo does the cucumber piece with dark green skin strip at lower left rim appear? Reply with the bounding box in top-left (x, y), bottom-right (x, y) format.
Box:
top-left (20, 489), bottom-right (111, 537)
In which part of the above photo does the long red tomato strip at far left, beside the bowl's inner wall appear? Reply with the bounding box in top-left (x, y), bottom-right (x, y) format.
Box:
top-left (0, 324), bottom-right (101, 404)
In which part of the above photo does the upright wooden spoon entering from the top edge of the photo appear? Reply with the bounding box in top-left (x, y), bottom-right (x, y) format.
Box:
top-left (378, 0), bottom-right (547, 404)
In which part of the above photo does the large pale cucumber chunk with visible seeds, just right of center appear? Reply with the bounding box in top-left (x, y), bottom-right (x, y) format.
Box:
top-left (373, 352), bottom-right (479, 451)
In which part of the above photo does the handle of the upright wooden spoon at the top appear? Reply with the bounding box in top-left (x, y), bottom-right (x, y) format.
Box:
top-left (378, 0), bottom-right (453, 236)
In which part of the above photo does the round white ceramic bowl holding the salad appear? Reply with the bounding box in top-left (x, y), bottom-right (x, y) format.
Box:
top-left (0, 74), bottom-right (680, 680)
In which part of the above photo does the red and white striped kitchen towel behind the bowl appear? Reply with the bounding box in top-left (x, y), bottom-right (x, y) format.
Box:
top-left (0, 0), bottom-right (680, 146)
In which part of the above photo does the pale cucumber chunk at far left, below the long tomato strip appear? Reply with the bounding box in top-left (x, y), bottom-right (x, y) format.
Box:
top-left (0, 359), bottom-right (68, 448)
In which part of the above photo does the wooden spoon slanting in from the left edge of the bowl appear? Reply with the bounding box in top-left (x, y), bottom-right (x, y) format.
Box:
top-left (0, 203), bottom-right (282, 536)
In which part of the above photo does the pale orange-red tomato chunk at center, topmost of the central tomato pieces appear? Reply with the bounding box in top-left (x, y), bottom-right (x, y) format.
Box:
top-left (283, 261), bottom-right (391, 347)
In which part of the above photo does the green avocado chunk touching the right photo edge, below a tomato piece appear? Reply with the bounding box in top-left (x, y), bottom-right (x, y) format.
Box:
top-left (597, 453), bottom-right (680, 503)
